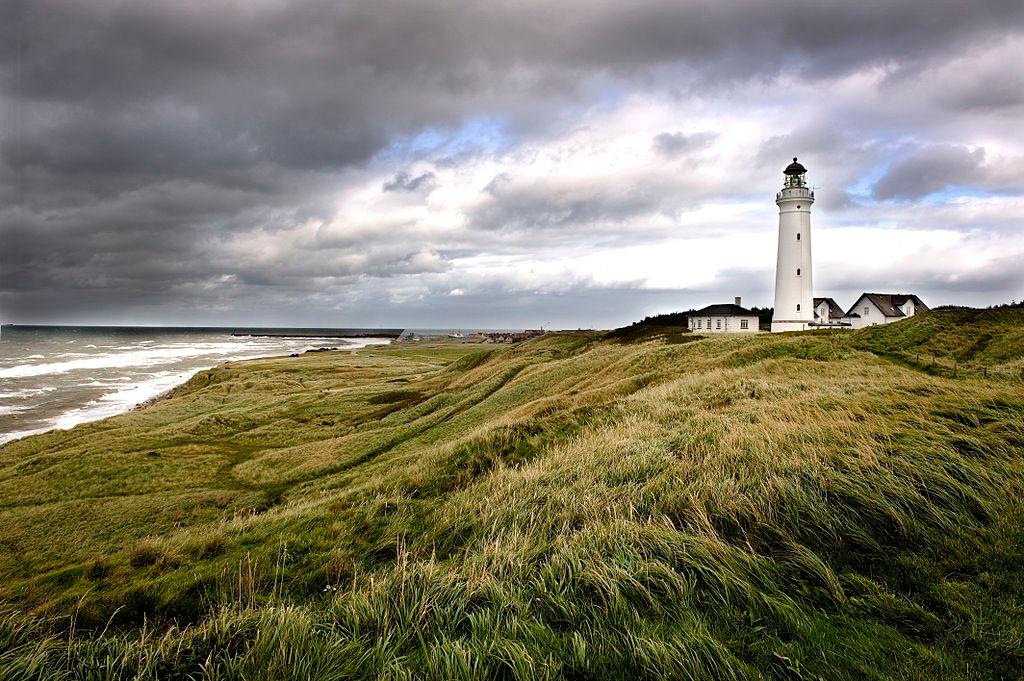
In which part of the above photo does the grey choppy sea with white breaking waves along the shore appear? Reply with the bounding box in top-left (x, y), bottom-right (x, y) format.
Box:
top-left (0, 326), bottom-right (402, 443)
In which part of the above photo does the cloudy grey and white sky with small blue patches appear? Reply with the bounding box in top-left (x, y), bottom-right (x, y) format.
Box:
top-left (0, 0), bottom-right (1024, 329)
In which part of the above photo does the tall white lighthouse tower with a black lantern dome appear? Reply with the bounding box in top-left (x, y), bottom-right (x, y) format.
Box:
top-left (771, 158), bottom-right (814, 333)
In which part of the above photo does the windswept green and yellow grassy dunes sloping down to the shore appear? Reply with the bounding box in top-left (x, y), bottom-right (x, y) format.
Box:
top-left (0, 310), bottom-right (1024, 679)
